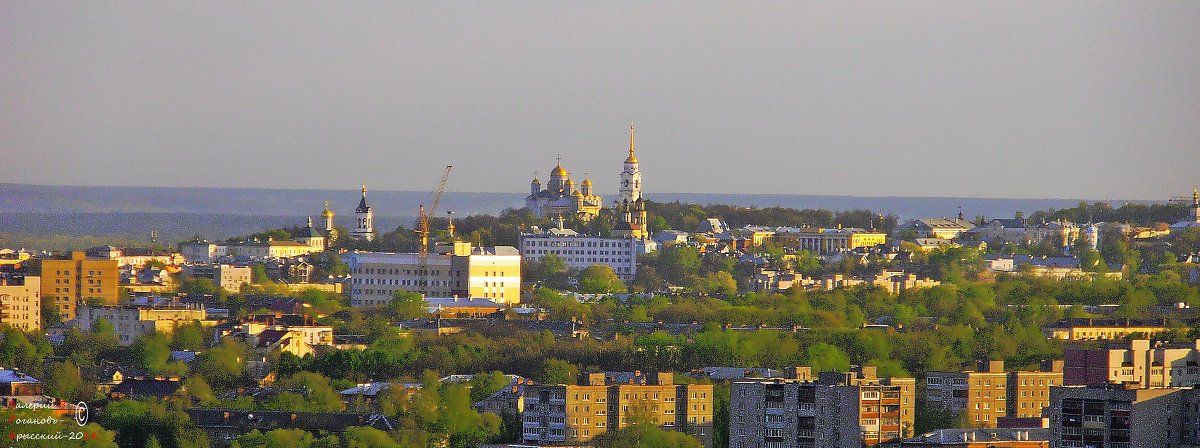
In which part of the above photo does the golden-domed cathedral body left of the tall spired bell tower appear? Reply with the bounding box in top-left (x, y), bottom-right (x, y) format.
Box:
top-left (526, 161), bottom-right (604, 221)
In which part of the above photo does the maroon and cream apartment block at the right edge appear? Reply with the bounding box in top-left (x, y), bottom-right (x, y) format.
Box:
top-left (1063, 339), bottom-right (1200, 388)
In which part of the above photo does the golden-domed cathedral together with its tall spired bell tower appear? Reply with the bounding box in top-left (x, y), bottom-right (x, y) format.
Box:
top-left (526, 125), bottom-right (642, 221)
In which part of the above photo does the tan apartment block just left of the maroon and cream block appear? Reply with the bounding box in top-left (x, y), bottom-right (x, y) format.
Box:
top-left (925, 360), bottom-right (1062, 428)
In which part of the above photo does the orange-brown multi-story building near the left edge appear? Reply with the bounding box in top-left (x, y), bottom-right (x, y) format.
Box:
top-left (42, 251), bottom-right (121, 322)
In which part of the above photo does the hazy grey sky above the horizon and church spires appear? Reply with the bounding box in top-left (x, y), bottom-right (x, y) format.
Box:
top-left (0, 0), bottom-right (1200, 198)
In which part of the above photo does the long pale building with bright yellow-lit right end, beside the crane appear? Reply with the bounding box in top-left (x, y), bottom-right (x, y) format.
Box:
top-left (343, 241), bottom-right (521, 306)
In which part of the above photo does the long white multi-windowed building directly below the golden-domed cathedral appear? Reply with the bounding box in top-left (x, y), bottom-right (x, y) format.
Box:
top-left (520, 227), bottom-right (658, 281)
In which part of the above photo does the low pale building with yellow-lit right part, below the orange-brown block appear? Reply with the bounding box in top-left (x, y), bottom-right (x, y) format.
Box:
top-left (70, 303), bottom-right (216, 346)
